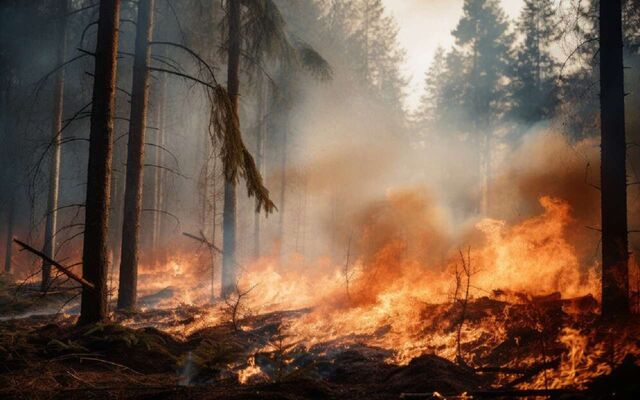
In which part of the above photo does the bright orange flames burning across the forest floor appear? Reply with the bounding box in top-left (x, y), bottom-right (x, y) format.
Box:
top-left (117, 191), bottom-right (640, 389)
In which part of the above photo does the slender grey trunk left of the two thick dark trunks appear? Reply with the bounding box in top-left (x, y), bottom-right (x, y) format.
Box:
top-left (40, 0), bottom-right (68, 291)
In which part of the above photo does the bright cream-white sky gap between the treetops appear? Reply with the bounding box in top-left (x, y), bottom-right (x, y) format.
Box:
top-left (383, 0), bottom-right (522, 110)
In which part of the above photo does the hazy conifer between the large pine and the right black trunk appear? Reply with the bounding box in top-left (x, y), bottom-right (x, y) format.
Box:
top-left (510, 0), bottom-right (558, 123)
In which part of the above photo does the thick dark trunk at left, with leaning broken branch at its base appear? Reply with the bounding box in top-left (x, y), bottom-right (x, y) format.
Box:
top-left (78, 0), bottom-right (120, 325)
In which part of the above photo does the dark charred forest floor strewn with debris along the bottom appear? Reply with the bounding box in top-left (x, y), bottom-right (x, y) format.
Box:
top-left (0, 276), bottom-right (640, 400)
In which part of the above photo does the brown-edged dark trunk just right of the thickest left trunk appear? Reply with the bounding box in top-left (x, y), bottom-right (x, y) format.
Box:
top-left (118, 0), bottom-right (155, 309)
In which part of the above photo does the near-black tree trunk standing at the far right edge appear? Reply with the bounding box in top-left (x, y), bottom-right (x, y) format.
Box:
top-left (600, 0), bottom-right (629, 318)
